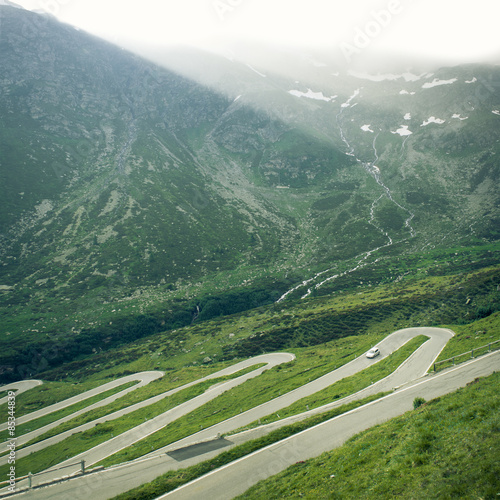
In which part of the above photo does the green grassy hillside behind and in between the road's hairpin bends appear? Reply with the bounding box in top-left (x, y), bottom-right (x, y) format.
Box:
top-left (1, 254), bottom-right (500, 492)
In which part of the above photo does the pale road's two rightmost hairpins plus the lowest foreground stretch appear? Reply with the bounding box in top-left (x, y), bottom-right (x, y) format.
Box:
top-left (1, 328), bottom-right (500, 500)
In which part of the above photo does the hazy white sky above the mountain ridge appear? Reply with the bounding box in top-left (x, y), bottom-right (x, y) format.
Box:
top-left (9, 0), bottom-right (500, 63)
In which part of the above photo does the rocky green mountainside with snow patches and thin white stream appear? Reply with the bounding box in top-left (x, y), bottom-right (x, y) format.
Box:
top-left (0, 5), bottom-right (500, 378)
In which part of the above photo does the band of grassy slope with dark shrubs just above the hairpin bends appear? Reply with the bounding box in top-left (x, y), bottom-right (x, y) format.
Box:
top-left (11, 254), bottom-right (500, 381)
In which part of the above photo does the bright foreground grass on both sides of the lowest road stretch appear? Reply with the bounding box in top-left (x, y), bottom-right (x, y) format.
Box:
top-left (106, 374), bottom-right (499, 500)
